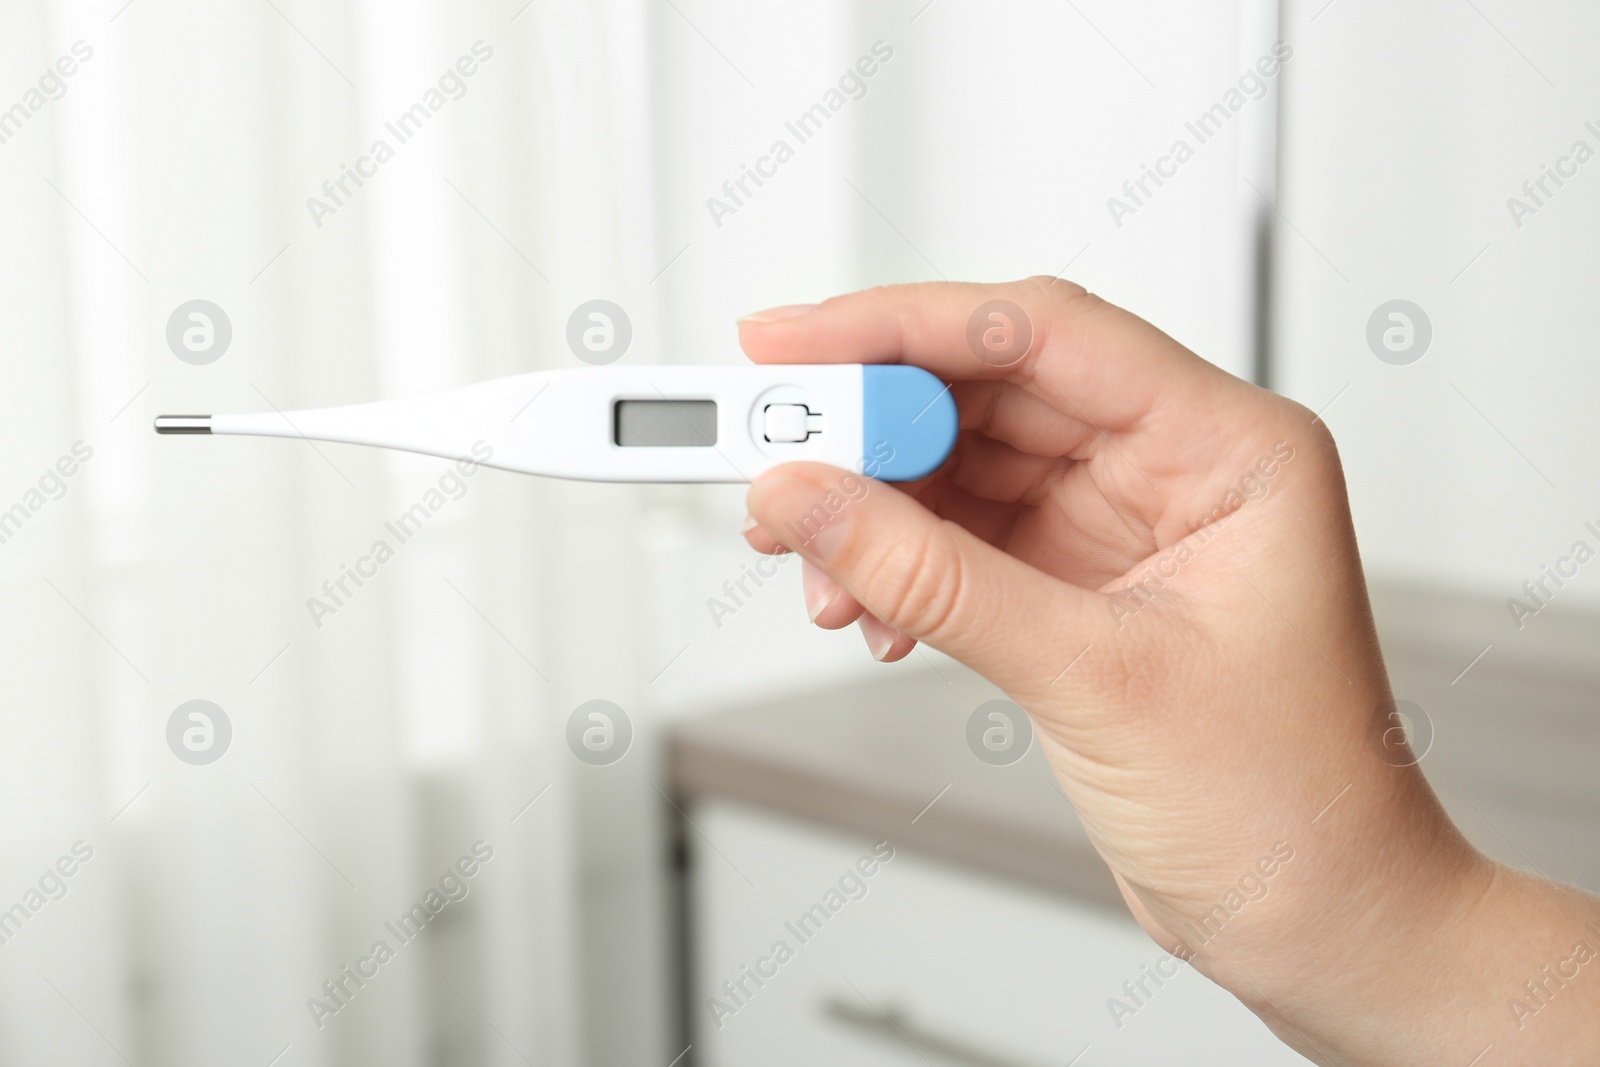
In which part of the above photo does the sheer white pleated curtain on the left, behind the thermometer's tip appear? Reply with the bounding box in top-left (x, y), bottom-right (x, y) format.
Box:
top-left (0, 0), bottom-right (652, 1064)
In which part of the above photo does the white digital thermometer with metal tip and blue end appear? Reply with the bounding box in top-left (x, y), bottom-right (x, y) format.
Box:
top-left (155, 363), bottom-right (957, 482)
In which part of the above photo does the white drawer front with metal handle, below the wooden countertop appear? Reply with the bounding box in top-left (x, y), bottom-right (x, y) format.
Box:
top-left (691, 800), bottom-right (1307, 1067)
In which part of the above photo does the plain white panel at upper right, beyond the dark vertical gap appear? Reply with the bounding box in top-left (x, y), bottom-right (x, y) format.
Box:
top-left (1277, 0), bottom-right (1600, 633)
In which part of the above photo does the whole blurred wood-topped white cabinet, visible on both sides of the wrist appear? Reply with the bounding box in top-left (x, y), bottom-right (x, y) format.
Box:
top-left (670, 587), bottom-right (1600, 1067)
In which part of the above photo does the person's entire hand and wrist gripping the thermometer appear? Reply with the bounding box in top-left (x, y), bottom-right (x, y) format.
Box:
top-left (739, 278), bottom-right (1600, 1067)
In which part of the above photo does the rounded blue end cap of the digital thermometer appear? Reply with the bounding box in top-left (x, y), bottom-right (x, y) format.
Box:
top-left (861, 363), bottom-right (957, 482)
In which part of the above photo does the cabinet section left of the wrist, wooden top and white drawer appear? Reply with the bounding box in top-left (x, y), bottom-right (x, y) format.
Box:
top-left (670, 659), bottom-right (1304, 1067)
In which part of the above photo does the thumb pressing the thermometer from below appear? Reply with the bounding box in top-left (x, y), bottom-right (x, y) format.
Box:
top-left (747, 464), bottom-right (1099, 694)
